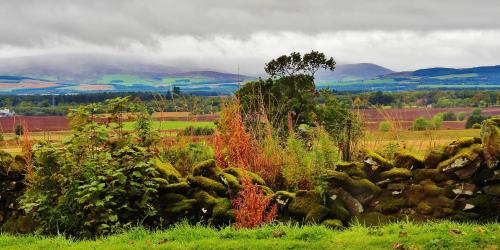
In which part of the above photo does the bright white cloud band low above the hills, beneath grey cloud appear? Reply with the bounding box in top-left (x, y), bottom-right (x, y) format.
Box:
top-left (0, 29), bottom-right (500, 74)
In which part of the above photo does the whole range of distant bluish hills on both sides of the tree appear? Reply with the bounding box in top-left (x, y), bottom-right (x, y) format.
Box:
top-left (0, 55), bottom-right (500, 95)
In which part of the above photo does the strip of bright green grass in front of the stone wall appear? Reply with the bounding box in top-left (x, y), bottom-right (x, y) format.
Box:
top-left (0, 221), bottom-right (500, 250)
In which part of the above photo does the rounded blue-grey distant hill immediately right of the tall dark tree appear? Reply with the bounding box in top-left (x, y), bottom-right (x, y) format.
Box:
top-left (316, 63), bottom-right (394, 82)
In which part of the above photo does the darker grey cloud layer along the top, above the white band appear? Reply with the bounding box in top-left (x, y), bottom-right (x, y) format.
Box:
top-left (0, 0), bottom-right (500, 45)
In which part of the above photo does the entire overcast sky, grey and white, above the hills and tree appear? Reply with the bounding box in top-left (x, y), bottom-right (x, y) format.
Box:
top-left (0, 0), bottom-right (500, 74)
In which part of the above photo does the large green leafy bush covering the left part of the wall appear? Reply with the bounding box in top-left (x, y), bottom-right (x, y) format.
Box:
top-left (20, 98), bottom-right (165, 237)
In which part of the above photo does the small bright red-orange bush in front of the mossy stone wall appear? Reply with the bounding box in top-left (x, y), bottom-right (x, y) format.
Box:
top-left (232, 178), bottom-right (278, 228)
